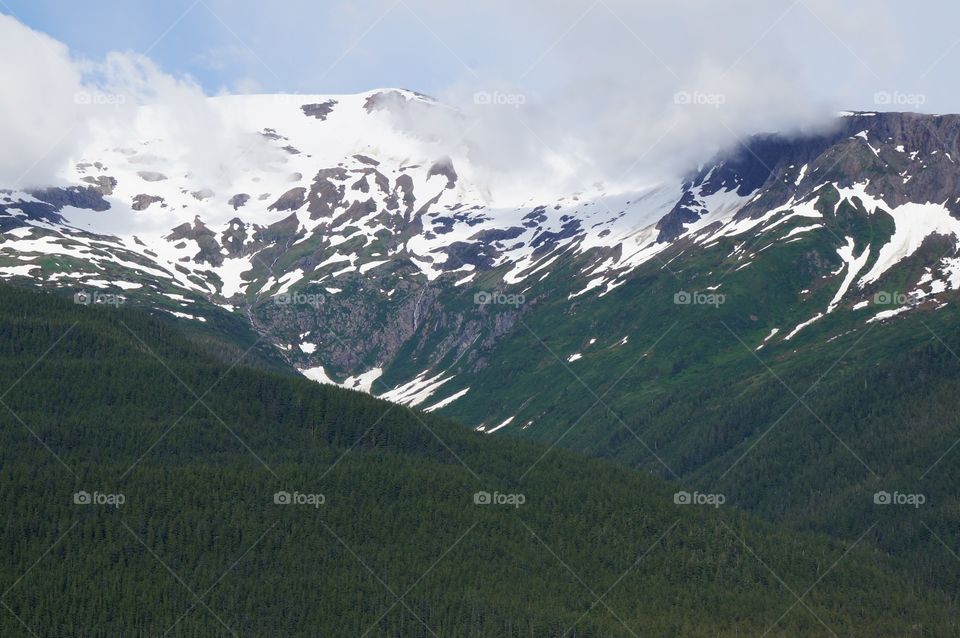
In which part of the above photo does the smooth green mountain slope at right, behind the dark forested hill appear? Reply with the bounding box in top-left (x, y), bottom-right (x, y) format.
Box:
top-left (426, 192), bottom-right (960, 587)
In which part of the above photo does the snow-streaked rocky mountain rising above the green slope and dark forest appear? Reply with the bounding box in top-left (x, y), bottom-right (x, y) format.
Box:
top-left (0, 89), bottom-right (960, 428)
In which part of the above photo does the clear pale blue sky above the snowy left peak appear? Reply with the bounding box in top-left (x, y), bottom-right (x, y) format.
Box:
top-left (0, 0), bottom-right (497, 93)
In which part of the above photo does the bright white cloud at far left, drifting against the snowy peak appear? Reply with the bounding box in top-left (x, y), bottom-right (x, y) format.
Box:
top-left (0, 15), bottom-right (276, 189)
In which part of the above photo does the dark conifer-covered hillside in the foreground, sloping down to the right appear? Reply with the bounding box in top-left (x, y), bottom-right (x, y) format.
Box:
top-left (0, 287), bottom-right (956, 637)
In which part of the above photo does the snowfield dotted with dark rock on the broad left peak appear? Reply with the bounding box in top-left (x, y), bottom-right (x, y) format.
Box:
top-left (2, 90), bottom-right (677, 301)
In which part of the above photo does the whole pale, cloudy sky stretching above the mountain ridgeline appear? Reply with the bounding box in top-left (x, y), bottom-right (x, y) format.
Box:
top-left (0, 0), bottom-right (960, 192)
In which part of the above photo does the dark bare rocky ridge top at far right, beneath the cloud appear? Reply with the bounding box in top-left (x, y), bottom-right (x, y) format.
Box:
top-left (657, 113), bottom-right (960, 242)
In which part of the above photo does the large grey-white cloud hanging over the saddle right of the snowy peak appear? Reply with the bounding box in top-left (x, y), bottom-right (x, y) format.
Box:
top-left (380, 0), bottom-right (888, 200)
